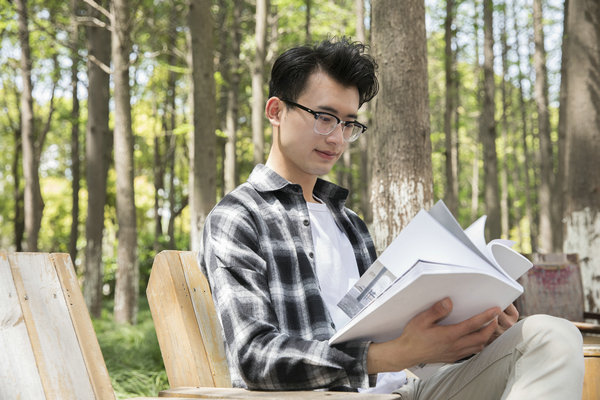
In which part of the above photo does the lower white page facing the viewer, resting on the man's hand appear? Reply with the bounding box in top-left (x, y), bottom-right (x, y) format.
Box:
top-left (329, 262), bottom-right (523, 344)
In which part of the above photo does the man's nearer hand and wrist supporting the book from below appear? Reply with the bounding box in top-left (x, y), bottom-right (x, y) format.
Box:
top-left (367, 298), bottom-right (502, 373)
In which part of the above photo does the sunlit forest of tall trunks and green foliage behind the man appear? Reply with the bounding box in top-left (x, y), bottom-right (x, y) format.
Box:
top-left (0, 0), bottom-right (600, 395)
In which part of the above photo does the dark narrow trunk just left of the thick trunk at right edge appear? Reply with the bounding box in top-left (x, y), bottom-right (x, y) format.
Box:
top-left (552, 0), bottom-right (569, 251)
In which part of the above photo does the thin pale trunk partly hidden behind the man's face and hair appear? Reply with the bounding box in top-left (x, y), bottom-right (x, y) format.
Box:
top-left (354, 0), bottom-right (373, 225)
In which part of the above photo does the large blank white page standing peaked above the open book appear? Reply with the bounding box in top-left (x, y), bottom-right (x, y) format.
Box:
top-left (377, 210), bottom-right (500, 276)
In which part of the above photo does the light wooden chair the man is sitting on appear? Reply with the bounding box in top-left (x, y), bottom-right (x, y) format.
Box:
top-left (146, 251), bottom-right (399, 400)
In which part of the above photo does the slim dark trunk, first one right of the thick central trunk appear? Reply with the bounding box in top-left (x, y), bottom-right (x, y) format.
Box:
top-left (444, 0), bottom-right (458, 215)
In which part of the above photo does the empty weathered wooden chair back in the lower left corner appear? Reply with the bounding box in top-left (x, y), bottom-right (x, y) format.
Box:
top-left (0, 251), bottom-right (162, 400)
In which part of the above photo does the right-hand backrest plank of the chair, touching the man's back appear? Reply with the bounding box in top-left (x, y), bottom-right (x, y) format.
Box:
top-left (179, 251), bottom-right (231, 387)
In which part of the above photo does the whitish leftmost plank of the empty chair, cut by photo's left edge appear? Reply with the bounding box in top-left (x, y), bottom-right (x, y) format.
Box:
top-left (0, 252), bottom-right (45, 399)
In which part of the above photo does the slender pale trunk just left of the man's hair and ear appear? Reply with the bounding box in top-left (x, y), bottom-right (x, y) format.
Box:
top-left (252, 0), bottom-right (268, 164)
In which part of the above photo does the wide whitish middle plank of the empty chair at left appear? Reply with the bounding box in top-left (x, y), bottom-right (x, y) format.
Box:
top-left (8, 253), bottom-right (94, 400)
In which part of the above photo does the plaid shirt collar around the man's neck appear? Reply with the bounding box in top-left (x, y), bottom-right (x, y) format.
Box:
top-left (248, 164), bottom-right (348, 203)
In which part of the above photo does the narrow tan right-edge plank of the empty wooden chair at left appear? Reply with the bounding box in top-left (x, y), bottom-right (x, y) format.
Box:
top-left (50, 253), bottom-right (115, 400)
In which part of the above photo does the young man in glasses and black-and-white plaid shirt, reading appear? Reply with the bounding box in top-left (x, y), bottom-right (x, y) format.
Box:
top-left (199, 39), bottom-right (583, 399)
